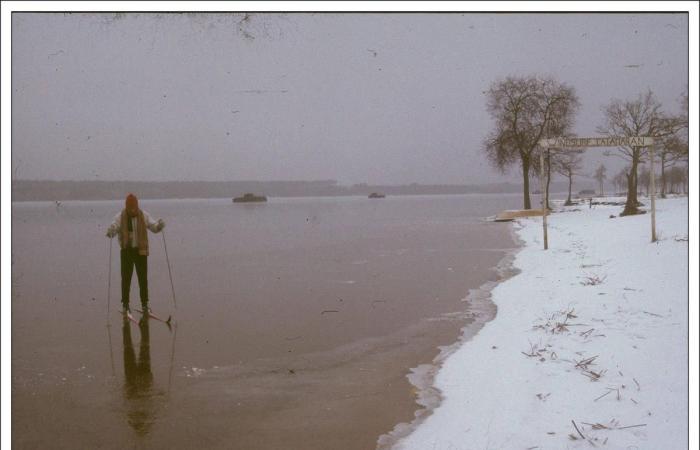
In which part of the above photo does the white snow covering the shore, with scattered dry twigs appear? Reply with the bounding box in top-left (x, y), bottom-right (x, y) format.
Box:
top-left (395, 198), bottom-right (688, 450)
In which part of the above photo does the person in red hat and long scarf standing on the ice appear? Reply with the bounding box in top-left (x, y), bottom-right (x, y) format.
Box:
top-left (107, 194), bottom-right (165, 313)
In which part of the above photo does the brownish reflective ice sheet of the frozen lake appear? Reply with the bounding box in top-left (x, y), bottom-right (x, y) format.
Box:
top-left (12, 199), bottom-right (517, 449)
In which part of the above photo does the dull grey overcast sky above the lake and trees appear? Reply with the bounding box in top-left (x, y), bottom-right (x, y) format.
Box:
top-left (12, 13), bottom-right (688, 184)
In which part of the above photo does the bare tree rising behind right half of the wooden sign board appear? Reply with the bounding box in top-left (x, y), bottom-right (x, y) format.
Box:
top-left (599, 90), bottom-right (679, 216)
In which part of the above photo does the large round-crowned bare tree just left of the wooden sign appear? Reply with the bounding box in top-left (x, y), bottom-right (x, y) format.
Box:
top-left (484, 76), bottom-right (579, 209)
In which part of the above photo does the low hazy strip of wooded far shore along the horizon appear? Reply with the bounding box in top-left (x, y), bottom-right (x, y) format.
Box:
top-left (12, 180), bottom-right (587, 202)
